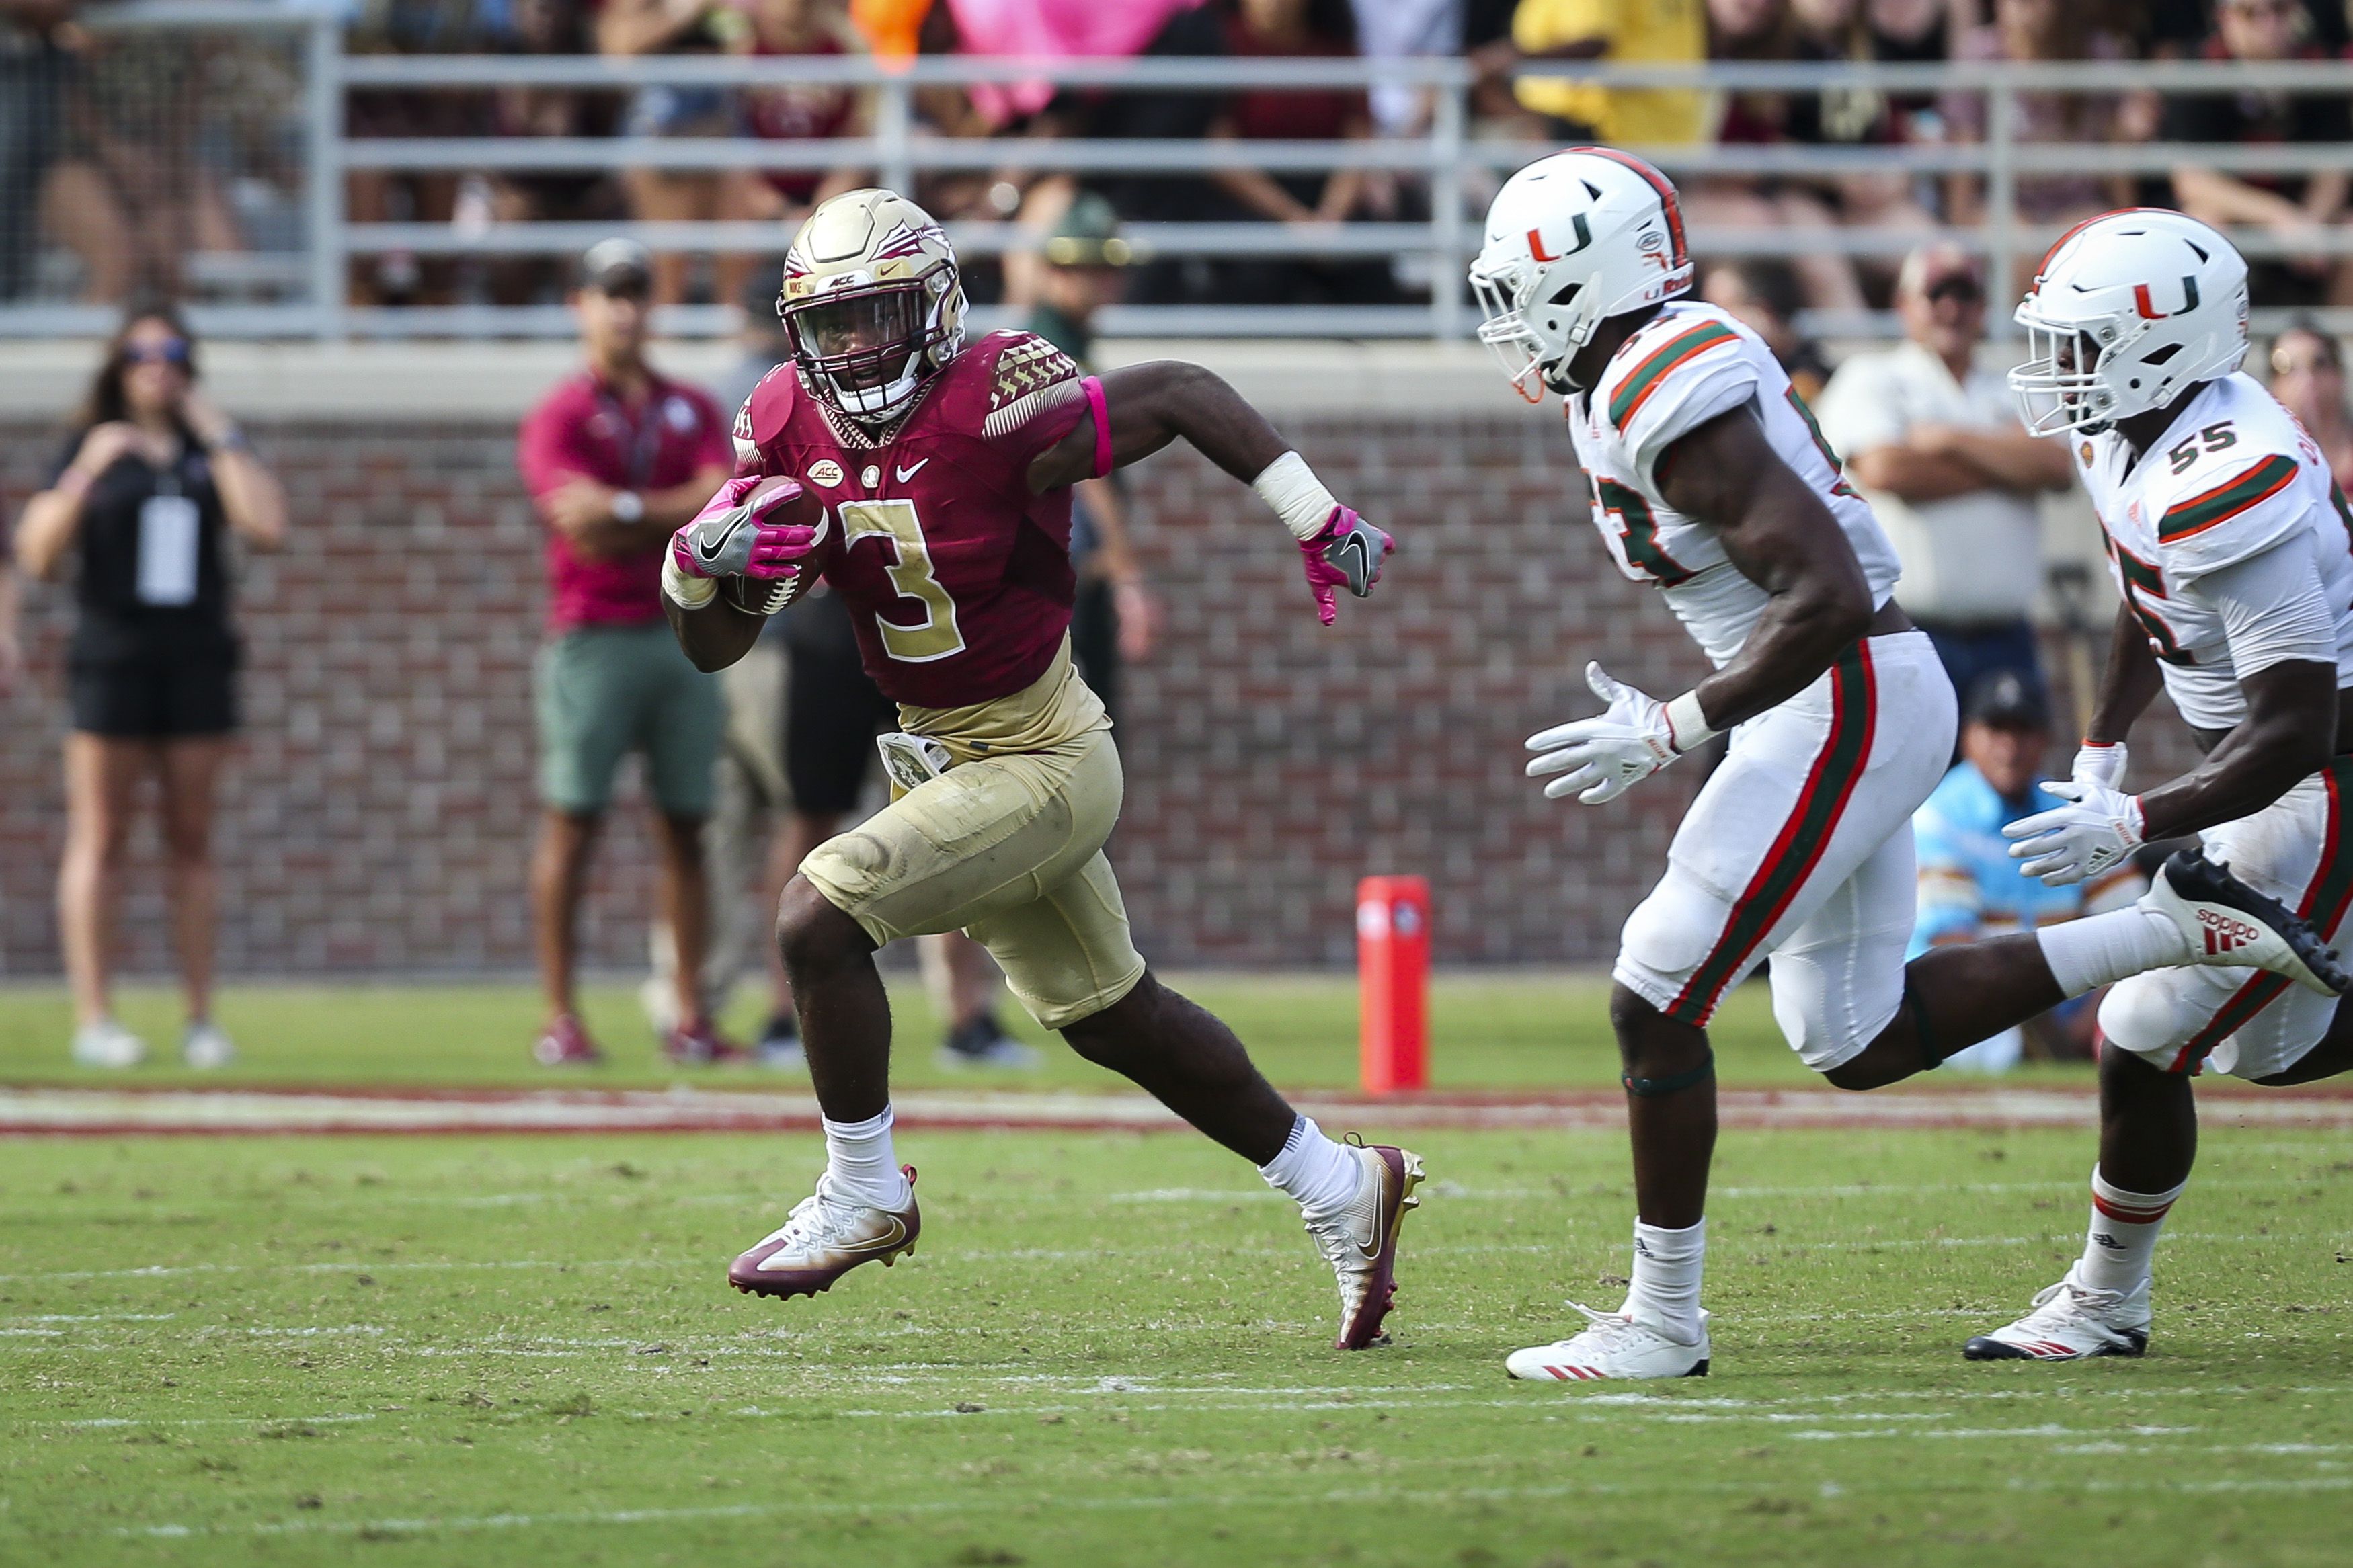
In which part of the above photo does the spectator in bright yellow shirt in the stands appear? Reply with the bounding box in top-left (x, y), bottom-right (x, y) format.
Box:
top-left (1511, 0), bottom-right (1711, 146)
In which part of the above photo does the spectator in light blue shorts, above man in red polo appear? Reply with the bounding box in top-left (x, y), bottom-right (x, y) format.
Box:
top-left (596, 0), bottom-right (753, 306)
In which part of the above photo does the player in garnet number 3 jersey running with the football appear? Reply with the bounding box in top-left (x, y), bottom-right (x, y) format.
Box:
top-left (664, 190), bottom-right (1421, 1350)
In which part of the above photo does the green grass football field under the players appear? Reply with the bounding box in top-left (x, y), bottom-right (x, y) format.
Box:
top-left (0, 981), bottom-right (2353, 1568)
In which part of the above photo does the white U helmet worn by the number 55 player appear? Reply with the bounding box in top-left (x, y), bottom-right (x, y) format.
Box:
top-left (2009, 207), bottom-right (2247, 435)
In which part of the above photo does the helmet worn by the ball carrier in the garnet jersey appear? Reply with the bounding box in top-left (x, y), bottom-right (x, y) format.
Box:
top-left (776, 190), bottom-right (965, 421)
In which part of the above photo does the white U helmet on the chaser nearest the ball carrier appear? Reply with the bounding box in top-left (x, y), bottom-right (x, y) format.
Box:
top-left (1471, 148), bottom-right (1692, 402)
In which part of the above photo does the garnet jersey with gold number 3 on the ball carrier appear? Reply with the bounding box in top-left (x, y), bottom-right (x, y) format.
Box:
top-left (734, 331), bottom-right (1087, 708)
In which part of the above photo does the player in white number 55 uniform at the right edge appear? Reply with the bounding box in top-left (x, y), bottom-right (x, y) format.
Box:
top-left (1965, 209), bottom-right (2353, 1361)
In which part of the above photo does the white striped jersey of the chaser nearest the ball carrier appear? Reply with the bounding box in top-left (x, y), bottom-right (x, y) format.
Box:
top-left (1570, 301), bottom-right (1899, 667)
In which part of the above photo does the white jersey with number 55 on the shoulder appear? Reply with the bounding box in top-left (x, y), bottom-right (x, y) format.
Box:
top-left (2075, 374), bottom-right (2353, 729)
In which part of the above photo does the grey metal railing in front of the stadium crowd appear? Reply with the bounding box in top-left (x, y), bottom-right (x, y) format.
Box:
top-left (0, 0), bottom-right (2353, 339)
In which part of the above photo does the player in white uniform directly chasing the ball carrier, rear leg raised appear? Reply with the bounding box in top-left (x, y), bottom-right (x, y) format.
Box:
top-left (1471, 148), bottom-right (2342, 1383)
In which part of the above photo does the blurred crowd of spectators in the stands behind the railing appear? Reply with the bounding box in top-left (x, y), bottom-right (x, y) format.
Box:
top-left (0, 0), bottom-right (2353, 311)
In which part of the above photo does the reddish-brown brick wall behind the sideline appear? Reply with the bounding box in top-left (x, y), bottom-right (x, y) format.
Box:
top-left (0, 416), bottom-right (2202, 976)
